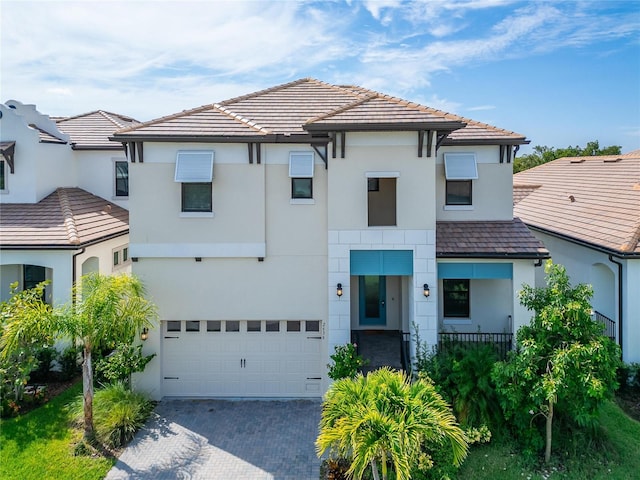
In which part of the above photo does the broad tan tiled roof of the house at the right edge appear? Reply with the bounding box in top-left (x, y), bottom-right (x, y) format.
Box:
top-left (513, 151), bottom-right (640, 255)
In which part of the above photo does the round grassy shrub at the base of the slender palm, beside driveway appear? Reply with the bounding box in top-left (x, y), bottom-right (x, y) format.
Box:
top-left (72, 382), bottom-right (153, 448)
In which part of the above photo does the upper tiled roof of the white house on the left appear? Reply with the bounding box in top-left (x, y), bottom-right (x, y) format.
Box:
top-left (56, 110), bottom-right (138, 150)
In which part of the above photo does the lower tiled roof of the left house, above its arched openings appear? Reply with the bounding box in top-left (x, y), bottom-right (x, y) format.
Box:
top-left (0, 188), bottom-right (129, 249)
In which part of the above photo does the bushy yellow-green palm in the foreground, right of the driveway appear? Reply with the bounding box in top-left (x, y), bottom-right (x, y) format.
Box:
top-left (316, 368), bottom-right (467, 480)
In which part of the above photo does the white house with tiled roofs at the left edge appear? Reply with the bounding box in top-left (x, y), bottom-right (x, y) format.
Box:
top-left (0, 101), bottom-right (132, 304)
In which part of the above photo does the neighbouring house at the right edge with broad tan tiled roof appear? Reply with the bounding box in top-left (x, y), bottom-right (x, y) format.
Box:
top-left (513, 150), bottom-right (640, 362)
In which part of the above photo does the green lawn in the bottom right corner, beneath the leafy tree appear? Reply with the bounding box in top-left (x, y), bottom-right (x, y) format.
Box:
top-left (458, 402), bottom-right (640, 480)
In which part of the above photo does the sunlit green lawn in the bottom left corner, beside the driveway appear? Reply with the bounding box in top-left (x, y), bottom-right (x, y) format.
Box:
top-left (0, 384), bottom-right (115, 480)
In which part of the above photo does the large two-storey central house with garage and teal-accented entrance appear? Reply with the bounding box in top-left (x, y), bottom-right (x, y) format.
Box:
top-left (112, 79), bottom-right (549, 398)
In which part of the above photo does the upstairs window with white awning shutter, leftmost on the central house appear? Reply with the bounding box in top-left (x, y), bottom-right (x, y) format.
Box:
top-left (174, 150), bottom-right (214, 214)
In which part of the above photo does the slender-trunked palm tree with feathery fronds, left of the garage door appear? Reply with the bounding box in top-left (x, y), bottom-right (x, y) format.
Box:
top-left (2, 273), bottom-right (156, 440)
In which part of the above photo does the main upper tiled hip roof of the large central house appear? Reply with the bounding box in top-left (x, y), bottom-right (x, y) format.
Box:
top-left (114, 78), bottom-right (528, 144)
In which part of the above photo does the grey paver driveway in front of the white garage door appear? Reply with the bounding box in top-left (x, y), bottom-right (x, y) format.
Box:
top-left (106, 400), bottom-right (321, 480)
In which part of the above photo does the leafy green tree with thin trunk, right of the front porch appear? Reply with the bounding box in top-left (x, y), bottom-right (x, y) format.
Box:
top-left (493, 261), bottom-right (620, 463)
